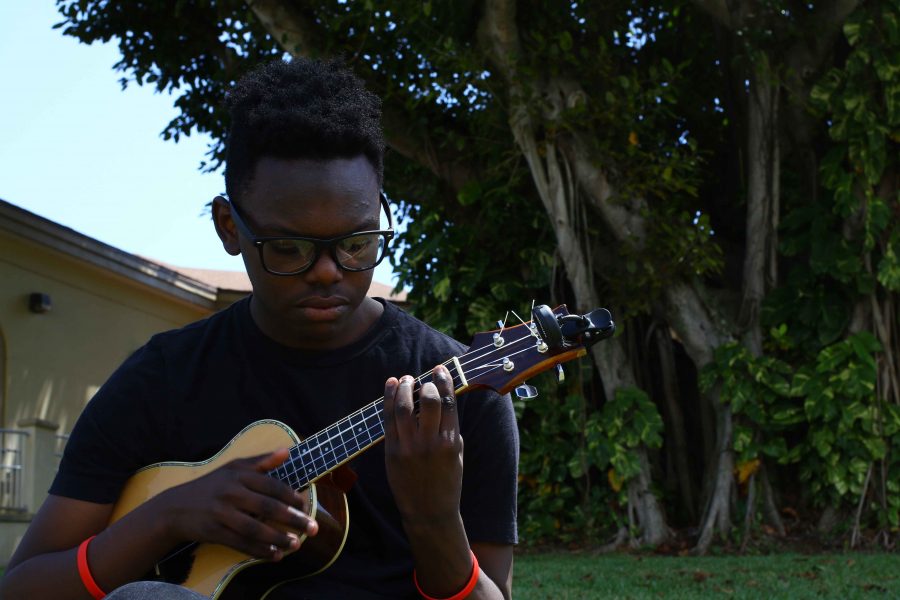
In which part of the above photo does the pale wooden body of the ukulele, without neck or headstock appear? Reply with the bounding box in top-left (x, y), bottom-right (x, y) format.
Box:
top-left (110, 420), bottom-right (349, 600)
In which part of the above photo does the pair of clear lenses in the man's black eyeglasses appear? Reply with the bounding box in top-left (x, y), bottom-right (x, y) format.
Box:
top-left (262, 233), bottom-right (387, 273)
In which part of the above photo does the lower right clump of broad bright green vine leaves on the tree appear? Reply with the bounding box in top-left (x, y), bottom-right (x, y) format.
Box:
top-left (701, 327), bottom-right (900, 528)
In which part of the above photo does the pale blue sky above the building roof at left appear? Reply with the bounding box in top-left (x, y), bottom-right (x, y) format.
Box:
top-left (0, 0), bottom-right (393, 284)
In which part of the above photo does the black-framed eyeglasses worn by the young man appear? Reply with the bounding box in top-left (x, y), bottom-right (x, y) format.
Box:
top-left (220, 192), bottom-right (394, 275)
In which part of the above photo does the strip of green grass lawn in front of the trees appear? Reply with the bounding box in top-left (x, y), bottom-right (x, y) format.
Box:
top-left (513, 552), bottom-right (900, 600)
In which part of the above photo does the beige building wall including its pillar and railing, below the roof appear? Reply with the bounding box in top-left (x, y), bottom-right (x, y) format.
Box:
top-left (0, 224), bottom-right (214, 566)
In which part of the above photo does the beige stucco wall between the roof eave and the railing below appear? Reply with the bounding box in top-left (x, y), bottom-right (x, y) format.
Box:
top-left (0, 230), bottom-right (209, 433)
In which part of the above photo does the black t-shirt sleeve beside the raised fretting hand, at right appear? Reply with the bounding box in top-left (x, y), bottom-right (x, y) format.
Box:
top-left (460, 391), bottom-right (519, 544)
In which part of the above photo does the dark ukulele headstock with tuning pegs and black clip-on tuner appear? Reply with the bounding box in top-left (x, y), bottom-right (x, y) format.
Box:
top-left (458, 304), bottom-right (616, 397)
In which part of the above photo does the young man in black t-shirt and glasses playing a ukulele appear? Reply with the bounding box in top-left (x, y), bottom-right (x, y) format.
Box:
top-left (0, 60), bottom-right (518, 599)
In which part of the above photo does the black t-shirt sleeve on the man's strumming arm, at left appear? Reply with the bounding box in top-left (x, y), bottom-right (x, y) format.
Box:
top-left (50, 341), bottom-right (167, 504)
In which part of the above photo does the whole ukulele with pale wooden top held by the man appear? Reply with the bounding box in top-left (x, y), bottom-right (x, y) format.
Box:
top-left (110, 305), bottom-right (615, 600)
